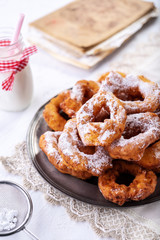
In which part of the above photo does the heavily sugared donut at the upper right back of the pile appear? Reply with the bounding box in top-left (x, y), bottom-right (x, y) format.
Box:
top-left (98, 71), bottom-right (160, 114)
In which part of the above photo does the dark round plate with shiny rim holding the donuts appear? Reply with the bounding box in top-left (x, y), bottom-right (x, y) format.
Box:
top-left (27, 96), bottom-right (160, 207)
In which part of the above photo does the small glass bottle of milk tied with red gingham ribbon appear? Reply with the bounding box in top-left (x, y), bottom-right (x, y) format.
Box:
top-left (0, 28), bottom-right (33, 111)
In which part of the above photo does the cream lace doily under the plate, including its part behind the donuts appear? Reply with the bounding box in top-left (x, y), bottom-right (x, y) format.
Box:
top-left (0, 34), bottom-right (160, 240)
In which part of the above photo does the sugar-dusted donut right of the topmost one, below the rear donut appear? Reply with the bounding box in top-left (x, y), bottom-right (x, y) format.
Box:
top-left (107, 112), bottom-right (160, 161)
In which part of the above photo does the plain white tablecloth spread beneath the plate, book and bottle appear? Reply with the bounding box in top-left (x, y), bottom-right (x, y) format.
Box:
top-left (0, 0), bottom-right (160, 240)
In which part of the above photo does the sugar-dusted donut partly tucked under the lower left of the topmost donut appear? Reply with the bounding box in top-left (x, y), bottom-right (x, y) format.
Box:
top-left (58, 118), bottom-right (112, 176)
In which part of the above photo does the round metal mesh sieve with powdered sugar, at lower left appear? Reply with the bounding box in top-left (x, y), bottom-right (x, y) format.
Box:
top-left (0, 181), bottom-right (38, 240)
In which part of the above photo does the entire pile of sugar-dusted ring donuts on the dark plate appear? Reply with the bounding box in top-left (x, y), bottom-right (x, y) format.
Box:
top-left (39, 71), bottom-right (160, 206)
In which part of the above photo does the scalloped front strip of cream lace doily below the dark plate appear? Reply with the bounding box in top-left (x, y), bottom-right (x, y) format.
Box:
top-left (0, 142), bottom-right (160, 240)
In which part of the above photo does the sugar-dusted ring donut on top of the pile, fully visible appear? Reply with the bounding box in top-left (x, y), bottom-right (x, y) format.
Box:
top-left (77, 91), bottom-right (126, 146)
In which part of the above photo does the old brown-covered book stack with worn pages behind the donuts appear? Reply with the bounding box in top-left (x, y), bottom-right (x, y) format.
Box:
top-left (29, 0), bottom-right (157, 69)
